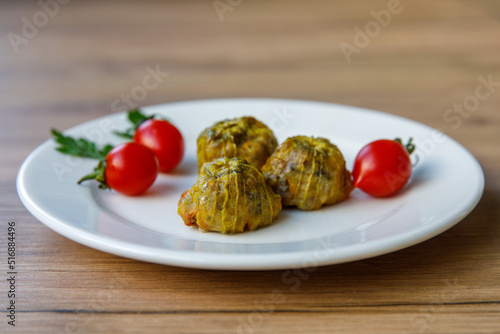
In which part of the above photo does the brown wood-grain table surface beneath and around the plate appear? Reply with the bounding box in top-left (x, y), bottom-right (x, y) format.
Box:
top-left (0, 0), bottom-right (500, 333)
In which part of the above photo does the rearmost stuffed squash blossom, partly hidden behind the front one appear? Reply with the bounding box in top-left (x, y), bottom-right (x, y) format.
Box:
top-left (198, 117), bottom-right (278, 170)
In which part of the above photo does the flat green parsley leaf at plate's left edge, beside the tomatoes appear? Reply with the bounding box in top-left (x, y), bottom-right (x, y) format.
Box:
top-left (51, 129), bottom-right (113, 160)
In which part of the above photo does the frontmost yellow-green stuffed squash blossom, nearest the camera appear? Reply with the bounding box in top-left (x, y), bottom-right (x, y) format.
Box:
top-left (178, 158), bottom-right (281, 234)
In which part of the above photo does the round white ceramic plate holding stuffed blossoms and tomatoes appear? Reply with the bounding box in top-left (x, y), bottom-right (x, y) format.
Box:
top-left (17, 99), bottom-right (484, 270)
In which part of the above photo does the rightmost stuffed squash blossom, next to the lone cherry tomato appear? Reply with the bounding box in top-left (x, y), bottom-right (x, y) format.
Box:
top-left (262, 136), bottom-right (353, 211)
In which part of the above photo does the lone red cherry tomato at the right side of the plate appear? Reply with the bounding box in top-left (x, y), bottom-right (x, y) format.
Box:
top-left (352, 139), bottom-right (412, 197)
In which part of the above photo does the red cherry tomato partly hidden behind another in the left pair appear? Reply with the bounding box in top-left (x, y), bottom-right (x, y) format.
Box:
top-left (134, 119), bottom-right (184, 172)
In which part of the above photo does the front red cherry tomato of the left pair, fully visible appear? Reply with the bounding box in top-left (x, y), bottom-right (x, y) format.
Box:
top-left (105, 142), bottom-right (158, 196)
